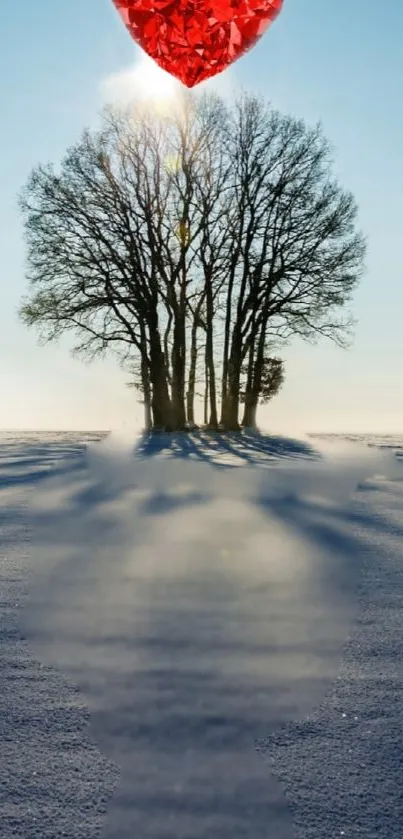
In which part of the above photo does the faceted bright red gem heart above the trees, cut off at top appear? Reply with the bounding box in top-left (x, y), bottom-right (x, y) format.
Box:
top-left (113, 0), bottom-right (283, 87)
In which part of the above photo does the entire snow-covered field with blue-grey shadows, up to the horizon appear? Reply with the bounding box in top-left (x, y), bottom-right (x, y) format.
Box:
top-left (0, 432), bottom-right (403, 839)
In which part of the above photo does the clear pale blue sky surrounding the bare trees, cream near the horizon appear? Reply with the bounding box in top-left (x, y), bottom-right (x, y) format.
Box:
top-left (0, 0), bottom-right (403, 433)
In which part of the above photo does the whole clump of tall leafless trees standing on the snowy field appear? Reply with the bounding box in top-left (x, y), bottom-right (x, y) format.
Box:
top-left (20, 94), bottom-right (365, 430)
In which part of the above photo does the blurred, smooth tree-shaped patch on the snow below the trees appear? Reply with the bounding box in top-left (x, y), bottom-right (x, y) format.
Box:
top-left (15, 434), bottom-right (403, 839)
